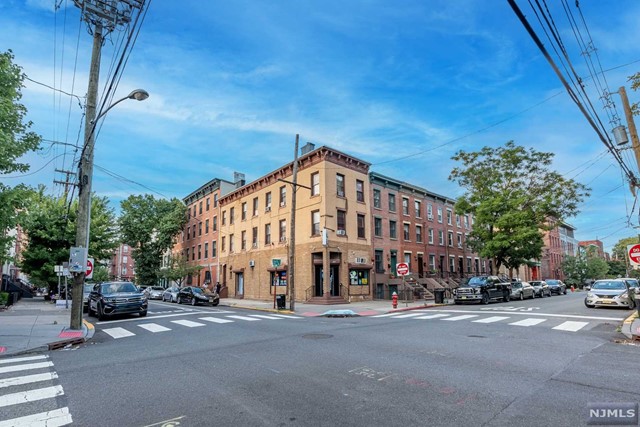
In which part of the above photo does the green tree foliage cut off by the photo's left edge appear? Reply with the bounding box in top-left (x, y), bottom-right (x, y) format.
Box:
top-left (0, 50), bottom-right (41, 264)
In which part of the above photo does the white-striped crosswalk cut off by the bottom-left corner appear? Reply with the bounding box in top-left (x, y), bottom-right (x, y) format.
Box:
top-left (0, 355), bottom-right (72, 427)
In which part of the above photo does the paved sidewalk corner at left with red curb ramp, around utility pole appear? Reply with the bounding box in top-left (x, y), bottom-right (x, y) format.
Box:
top-left (0, 297), bottom-right (94, 357)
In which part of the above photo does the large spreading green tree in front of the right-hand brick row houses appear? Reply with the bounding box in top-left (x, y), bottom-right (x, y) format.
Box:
top-left (449, 141), bottom-right (589, 274)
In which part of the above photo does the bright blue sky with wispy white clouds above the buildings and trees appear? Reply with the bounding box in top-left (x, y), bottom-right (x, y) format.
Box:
top-left (0, 0), bottom-right (640, 254)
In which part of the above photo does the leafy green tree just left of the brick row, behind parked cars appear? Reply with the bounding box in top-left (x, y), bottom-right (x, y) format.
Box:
top-left (120, 194), bottom-right (187, 286)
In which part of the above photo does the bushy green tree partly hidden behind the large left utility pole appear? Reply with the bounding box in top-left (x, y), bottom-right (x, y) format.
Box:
top-left (20, 186), bottom-right (118, 288)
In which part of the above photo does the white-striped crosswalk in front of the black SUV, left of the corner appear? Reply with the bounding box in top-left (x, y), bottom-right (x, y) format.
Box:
top-left (100, 313), bottom-right (303, 339)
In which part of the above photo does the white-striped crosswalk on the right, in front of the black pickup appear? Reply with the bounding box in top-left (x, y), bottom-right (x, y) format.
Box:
top-left (370, 310), bottom-right (589, 332)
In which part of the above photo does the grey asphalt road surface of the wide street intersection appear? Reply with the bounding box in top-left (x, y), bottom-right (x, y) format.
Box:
top-left (0, 293), bottom-right (640, 427)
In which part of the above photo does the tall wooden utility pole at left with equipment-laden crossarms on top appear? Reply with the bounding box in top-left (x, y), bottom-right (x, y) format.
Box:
top-left (70, 0), bottom-right (144, 329)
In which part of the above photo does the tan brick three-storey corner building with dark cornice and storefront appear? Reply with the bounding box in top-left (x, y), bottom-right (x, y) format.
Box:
top-left (218, 143), bottom-right (373, 304)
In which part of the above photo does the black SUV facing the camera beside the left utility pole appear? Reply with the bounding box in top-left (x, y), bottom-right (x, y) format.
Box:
top-left (88, 282), bottom-right (148, 320)
